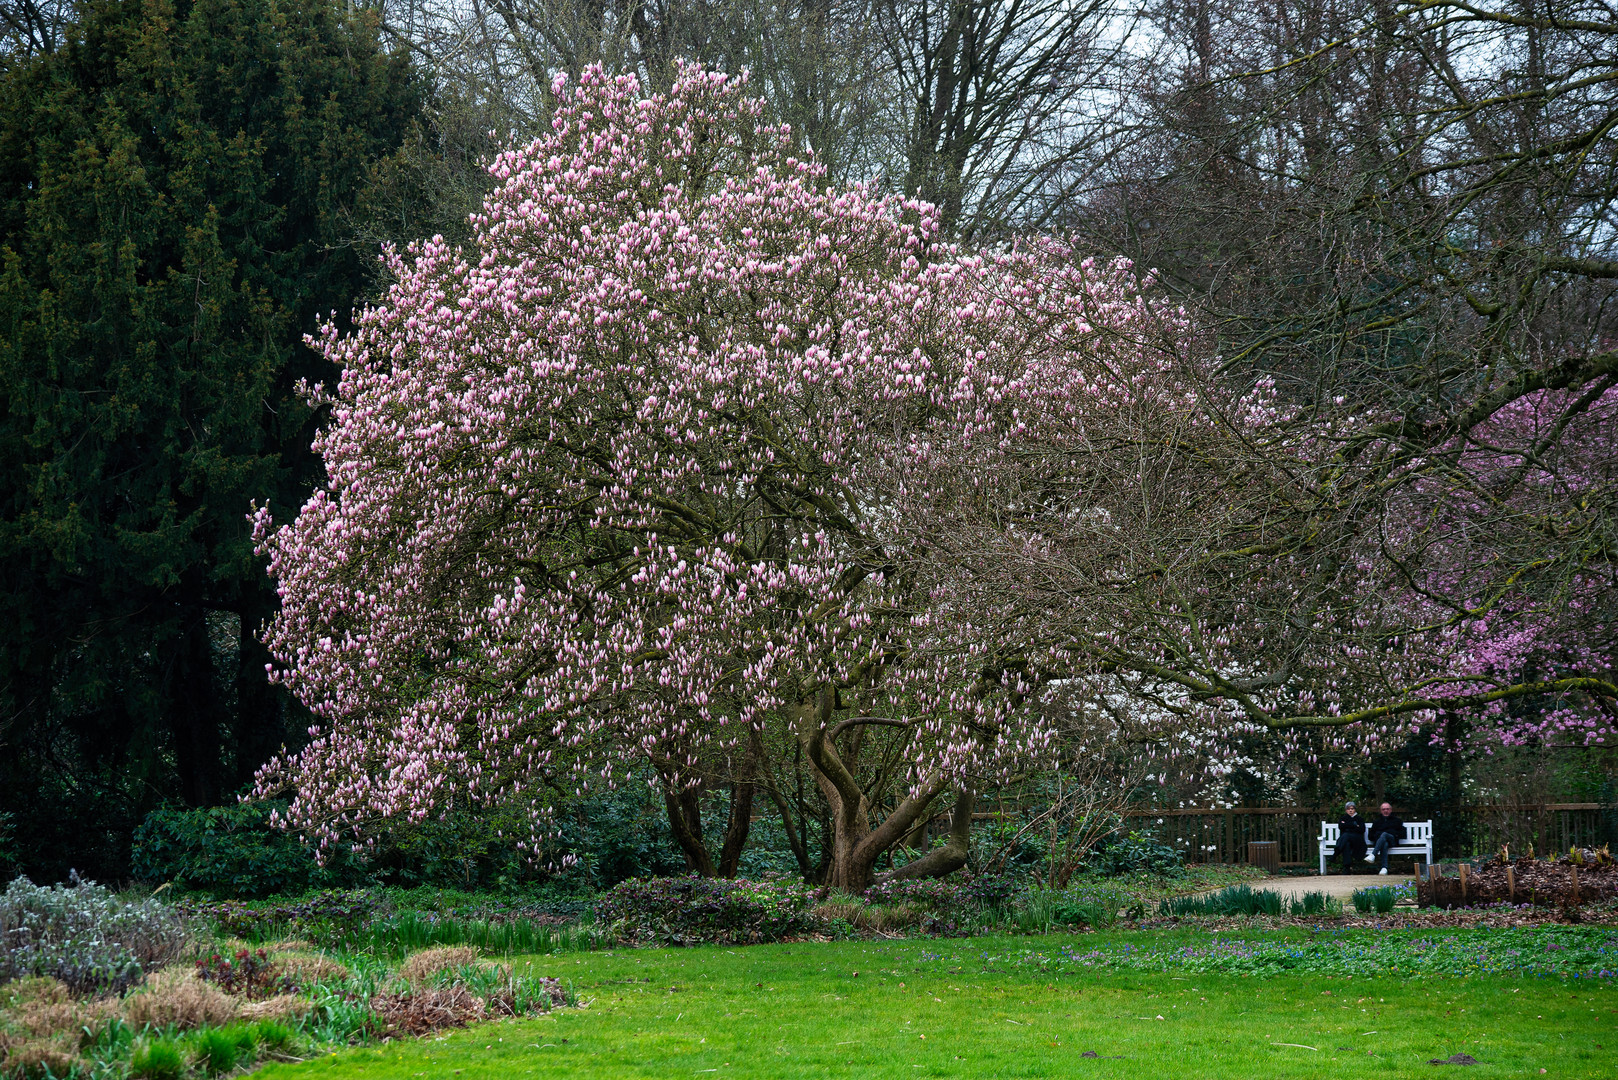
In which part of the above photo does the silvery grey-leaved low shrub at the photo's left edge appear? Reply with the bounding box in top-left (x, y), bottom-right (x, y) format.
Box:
top-left (0, 878), bottom-right (186, 991)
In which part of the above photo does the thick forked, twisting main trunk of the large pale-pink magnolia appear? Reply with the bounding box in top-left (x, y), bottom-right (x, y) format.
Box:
top-left (794, 687), bottom-right (976, 892)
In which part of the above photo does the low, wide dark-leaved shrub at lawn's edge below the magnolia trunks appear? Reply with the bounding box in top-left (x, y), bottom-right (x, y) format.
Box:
top-left (595, 876), bottom-right (825, 944)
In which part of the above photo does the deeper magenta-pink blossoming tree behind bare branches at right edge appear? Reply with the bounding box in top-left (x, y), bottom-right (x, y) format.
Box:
top-left (1396, 388), bottom-right (1618, 746)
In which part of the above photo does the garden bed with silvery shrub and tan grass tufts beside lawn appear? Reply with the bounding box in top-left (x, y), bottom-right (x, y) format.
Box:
top-left (0, 879), bottom-right (582, 1080)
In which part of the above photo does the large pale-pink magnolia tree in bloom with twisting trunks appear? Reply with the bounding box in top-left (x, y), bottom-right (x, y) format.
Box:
top-left (256, 71), bottom-right (1223, 887)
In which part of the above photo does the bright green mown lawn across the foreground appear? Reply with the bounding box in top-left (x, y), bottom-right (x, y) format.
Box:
top-left (257, 931), bottom-right (1618, 1080)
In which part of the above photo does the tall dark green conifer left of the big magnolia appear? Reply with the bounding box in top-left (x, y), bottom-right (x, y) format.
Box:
top-left (0, 0), bottom-right (419, 876)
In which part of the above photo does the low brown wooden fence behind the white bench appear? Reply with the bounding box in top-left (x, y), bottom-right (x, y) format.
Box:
top-left (1123, 803), bottom-right (1615, 865)
